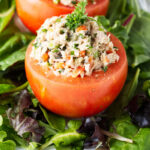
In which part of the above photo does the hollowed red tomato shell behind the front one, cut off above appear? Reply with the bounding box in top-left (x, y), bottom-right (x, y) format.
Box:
top-left (16, 0), bottom-right (109, 33)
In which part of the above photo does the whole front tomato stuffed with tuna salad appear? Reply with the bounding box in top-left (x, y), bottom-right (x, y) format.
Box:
top-left (25, 3), bottom-right (128, 117)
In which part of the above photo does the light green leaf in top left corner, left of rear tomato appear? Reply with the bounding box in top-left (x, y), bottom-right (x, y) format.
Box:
top-left (0, 0), bottom-right (15, 33)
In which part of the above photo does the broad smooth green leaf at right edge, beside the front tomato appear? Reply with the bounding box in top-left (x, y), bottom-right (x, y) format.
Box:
top-left (128, 12), bottom-right (150, 67)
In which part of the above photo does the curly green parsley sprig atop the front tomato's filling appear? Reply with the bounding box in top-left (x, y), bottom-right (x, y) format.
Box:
top-left (66, 0), bottom-right (88, 30)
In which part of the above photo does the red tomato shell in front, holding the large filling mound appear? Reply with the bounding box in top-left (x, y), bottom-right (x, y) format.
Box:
top-left (25, 34), bottom-right (128, 117)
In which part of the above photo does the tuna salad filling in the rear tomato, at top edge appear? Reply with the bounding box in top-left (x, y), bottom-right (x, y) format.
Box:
top-left (53, 0), bottom-right (96, 7)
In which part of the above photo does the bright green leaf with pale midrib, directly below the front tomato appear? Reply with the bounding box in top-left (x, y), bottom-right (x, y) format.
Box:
top-left (41, 120), bottom-right (86, 150)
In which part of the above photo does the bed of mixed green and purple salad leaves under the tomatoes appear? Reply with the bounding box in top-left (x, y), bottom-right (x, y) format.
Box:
top-left (0, 0), bottom-right (150, 150)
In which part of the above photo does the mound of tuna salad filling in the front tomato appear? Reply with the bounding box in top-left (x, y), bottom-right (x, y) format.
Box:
top-left (30, 15), bottom-right (119, 78)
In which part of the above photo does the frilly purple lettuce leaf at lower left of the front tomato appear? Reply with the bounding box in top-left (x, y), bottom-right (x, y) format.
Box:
top-left (7, 90), bottom-right (44, 142)
